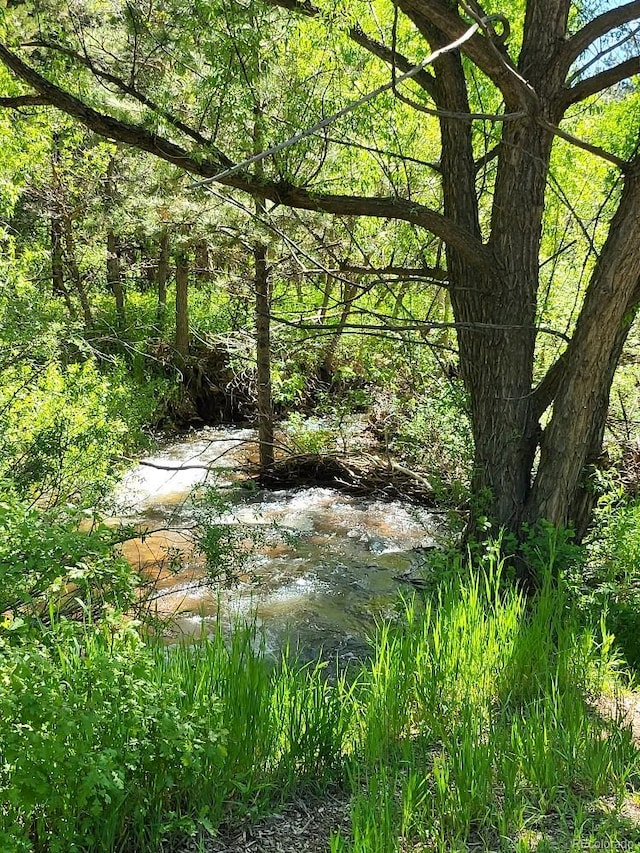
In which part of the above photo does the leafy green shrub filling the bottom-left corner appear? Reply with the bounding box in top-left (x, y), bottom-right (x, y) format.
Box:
top-left (0, 620), bottom-right (225, 853)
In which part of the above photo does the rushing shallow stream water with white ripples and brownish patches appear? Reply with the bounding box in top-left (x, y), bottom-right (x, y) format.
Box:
top-left (116, 428), bottom-right (438, 660)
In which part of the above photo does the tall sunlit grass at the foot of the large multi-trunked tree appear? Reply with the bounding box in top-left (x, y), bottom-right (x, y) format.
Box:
top-left (332, 556), bottom-right (640, 853)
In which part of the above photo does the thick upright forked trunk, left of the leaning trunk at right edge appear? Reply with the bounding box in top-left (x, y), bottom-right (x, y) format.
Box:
top-left (420, 8), bottom-right (568, 535)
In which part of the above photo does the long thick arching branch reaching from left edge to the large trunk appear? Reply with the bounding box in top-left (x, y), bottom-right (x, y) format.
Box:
top-left (0, 43), bottom-right (494, 268)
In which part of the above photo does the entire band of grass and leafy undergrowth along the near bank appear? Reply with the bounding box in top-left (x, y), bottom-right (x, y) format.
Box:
top-left (0, 556), bottom-right (640, 853)
